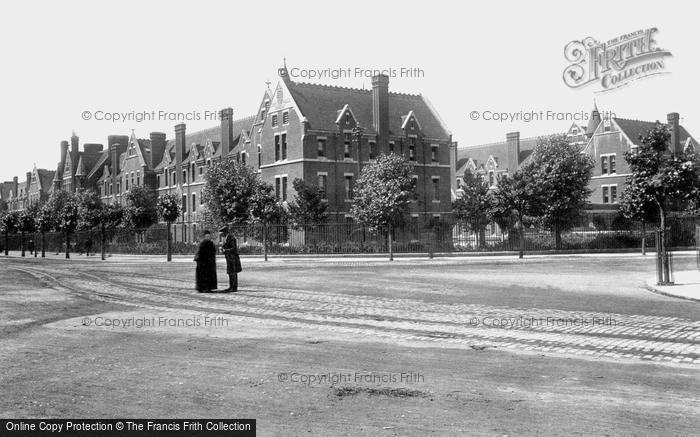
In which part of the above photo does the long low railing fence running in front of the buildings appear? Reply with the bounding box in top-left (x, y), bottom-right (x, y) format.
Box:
top-left (0, 215), bottom-right (700, 255)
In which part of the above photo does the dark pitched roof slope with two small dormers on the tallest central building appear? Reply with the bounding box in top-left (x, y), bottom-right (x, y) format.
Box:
top-left (286, 81), bottom-right (450, 138)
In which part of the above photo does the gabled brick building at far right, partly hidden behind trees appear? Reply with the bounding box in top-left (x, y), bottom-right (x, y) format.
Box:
top-left (456, 107), bottom-right (698, 209)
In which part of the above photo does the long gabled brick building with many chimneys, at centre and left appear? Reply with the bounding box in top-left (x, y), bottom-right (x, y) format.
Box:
top-left (3, 66), bottom-right (456, 238)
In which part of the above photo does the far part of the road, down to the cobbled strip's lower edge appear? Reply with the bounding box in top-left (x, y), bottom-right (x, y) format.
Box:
top-left (3, 256), bottom-right (700, 367)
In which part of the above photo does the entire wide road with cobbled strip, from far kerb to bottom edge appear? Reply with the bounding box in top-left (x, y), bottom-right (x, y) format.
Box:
top-left (0, 255), bottom-right (700, 435)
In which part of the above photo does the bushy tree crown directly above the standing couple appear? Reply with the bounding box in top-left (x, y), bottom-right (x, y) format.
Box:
top-left (202, 158), bottom-right (261, 224)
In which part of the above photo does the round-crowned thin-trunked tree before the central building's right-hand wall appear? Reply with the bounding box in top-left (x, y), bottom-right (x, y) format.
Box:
top-left (351, 153), bottom-right (414, 260)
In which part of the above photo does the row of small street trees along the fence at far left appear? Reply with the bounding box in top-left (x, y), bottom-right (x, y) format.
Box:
top-left (0, 187), bottom-right (179, 259)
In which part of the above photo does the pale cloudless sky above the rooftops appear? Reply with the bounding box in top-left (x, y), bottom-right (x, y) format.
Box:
top-left (0, 0), bottom-right (700, 180)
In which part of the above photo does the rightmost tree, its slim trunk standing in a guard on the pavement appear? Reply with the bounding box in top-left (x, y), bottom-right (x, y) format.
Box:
top-left (622, 123), bottom-right (700, 282)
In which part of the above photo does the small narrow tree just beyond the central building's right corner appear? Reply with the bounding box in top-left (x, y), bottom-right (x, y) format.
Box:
top-left (452, 169), bottom-right (492, 246)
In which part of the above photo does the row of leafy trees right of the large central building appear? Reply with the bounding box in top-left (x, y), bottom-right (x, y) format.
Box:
top-left (453, 124), bottom-right (700, 262)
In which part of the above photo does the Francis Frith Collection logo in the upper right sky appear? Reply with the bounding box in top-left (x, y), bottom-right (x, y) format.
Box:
top-left (564, 27), bottom-right (672, 91)
